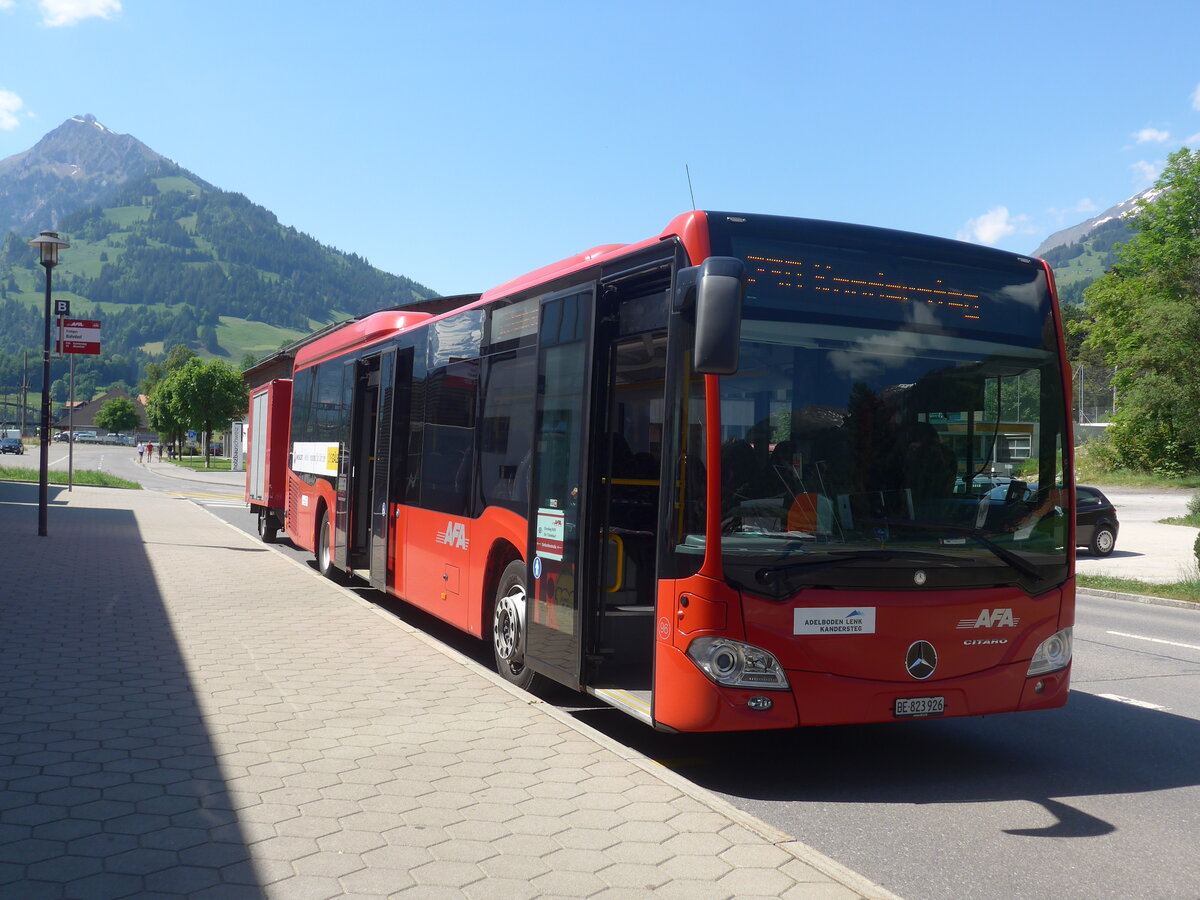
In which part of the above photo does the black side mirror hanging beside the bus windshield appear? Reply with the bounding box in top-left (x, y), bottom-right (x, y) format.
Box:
top-left (674, 257), bottom-right (745, 374)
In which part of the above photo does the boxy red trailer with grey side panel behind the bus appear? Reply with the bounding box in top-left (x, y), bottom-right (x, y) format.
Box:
top-left (246, 378), bottom-right (292, 544)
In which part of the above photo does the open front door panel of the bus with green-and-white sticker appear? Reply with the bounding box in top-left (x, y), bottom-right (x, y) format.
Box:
top-left (524, 286), bottom-right (598, 688)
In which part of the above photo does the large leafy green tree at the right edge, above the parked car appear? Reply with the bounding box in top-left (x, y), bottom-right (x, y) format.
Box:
top-left (1084, 148), bottom-right (1200, 475)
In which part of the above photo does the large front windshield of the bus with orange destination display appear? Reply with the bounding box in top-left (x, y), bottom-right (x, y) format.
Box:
top-left (679, 218), bottom-right (1069, 596)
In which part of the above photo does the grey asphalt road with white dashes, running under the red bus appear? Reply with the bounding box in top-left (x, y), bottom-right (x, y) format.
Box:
top-left (16, 448), bottom-right (1200, 900)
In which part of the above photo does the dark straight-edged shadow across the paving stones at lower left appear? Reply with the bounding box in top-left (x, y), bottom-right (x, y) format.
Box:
top-left (0, 484), bottom-right (262, 896)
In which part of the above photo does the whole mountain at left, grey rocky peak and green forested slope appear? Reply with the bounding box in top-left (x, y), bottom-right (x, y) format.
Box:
top-left (0, 115), bottom-right (437, 400)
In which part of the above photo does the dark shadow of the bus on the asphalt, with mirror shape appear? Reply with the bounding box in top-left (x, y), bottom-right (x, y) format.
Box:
top-left (580, 691), bottom-right (1200, 838)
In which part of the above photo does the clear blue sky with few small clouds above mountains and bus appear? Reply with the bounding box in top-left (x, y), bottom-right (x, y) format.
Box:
top-left (0, 0), bottom-right (1200, 294)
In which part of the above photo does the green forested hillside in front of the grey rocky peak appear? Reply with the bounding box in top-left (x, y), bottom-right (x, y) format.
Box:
top-left (0, 161), bottom-right (436, 398)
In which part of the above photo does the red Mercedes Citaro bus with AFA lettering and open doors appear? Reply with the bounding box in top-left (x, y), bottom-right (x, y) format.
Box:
top-left (248, 211), bottom-right (1075, 732)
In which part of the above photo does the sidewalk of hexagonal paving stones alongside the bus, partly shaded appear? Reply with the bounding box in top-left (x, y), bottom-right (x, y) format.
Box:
top-left (0, 484), bottom-right (892, 900)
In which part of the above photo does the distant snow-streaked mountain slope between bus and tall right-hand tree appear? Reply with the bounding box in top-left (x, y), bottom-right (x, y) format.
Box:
top-left (1033, 188), bottom-right (1158, 304)
